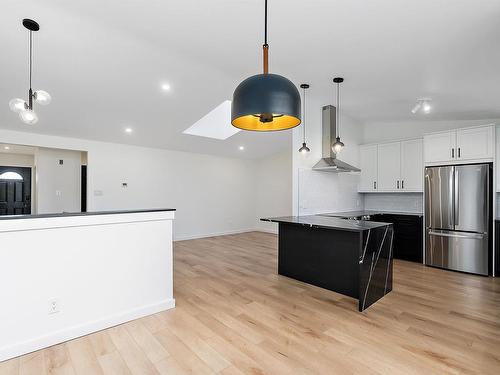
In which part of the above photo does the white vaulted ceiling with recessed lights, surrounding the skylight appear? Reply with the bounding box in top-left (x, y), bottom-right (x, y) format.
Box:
top-left (0, 0), bottom-right (500, 158)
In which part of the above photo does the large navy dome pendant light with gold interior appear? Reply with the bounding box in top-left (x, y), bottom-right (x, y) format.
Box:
top-left (231, 0), bottom-right (301, 132)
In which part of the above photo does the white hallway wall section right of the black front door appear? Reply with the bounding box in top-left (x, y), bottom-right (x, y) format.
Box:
top-left (35, 147), bottom-right (82, 214)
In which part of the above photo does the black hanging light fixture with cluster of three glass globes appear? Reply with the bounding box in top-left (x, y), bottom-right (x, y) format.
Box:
top-left (9, 18), bottom-right (52, 125)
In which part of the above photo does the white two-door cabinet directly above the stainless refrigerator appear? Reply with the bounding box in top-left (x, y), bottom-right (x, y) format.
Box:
top-left (424, 126), bottom-right (495, 164)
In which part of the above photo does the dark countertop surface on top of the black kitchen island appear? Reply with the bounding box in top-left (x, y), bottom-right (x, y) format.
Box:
top-left (260, 215), bottom-right (392, 232)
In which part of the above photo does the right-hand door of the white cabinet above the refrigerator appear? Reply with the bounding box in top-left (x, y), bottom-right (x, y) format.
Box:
top-left (456, 126), bottom-right (495, 160)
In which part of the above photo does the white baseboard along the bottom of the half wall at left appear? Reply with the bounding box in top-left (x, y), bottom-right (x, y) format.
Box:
top-left (0, 298), bottom-right (175, 362)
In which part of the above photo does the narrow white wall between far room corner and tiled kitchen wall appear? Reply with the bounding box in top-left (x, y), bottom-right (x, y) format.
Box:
top-left (255, 150), bottom-right (292, 232)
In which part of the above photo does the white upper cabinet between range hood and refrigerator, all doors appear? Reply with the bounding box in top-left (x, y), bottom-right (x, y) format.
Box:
top-left (359, 139), bottom-right (424, 193)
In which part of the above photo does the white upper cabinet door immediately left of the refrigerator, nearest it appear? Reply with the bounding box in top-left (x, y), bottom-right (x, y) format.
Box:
top-left (400, 139), bottom-right (424, 192)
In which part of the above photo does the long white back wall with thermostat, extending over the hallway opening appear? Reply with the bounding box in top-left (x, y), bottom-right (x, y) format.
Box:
top-left (0, 130), bottom-right (256, 240)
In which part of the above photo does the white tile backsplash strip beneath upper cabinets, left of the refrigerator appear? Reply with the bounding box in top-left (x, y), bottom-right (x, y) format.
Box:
top-left (363, 193), bottom-right (424, 212)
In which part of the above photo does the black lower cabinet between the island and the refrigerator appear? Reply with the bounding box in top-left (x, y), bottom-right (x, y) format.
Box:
top-left (371, 214), bottom-right (424, 263)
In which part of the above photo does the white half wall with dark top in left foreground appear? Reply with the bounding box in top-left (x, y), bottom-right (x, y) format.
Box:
top-left (0, 208), bottom-right (175, 361)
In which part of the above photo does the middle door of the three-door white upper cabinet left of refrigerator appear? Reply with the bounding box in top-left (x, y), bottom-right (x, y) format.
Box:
top-left (377, 142), bottom-right (401, 191)
